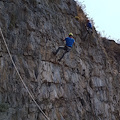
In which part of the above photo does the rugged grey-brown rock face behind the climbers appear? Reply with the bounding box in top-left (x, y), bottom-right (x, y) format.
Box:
top-left (0, 0), bottom-right (120, 120)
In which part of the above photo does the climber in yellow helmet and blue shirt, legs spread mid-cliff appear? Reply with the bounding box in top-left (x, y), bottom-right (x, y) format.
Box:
top-left (53, 33), bottom-right (75, 61)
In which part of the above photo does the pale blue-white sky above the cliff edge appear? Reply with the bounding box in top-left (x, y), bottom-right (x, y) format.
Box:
top-left (77, 0), bottom-right (120, 42)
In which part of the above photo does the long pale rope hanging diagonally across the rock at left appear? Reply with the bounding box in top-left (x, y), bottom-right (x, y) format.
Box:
top-left (0, 28), bottom-right (50, 120)
